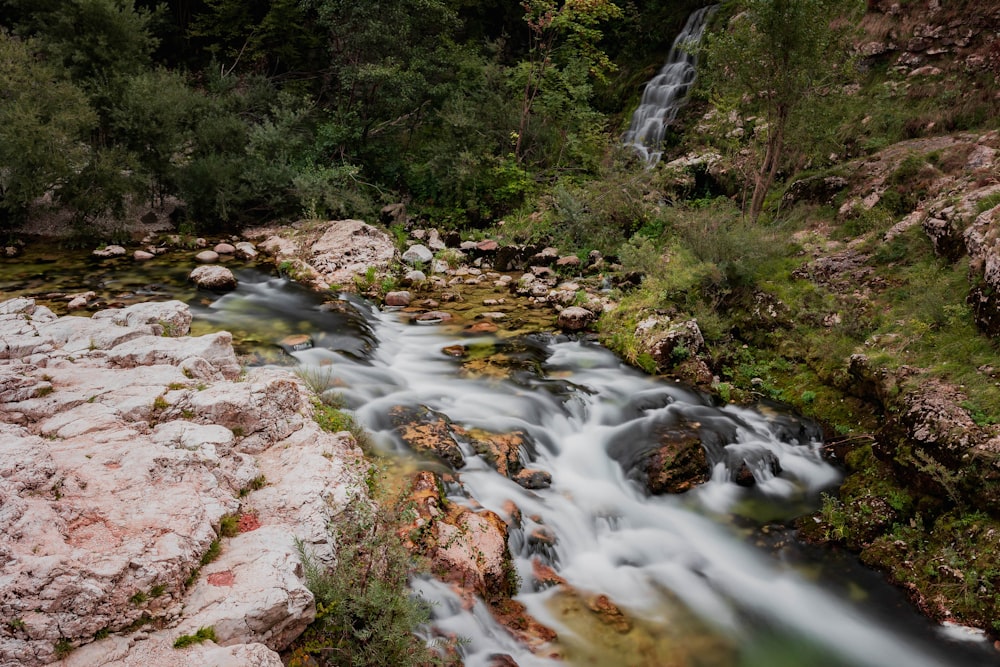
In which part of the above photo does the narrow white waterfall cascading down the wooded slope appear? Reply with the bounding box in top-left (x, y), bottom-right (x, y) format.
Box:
top-left (622, 5), bottom-right (718, 167)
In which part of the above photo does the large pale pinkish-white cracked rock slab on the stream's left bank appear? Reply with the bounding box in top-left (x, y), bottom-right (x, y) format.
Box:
top-left (0, 299), bottom-right (364, 667)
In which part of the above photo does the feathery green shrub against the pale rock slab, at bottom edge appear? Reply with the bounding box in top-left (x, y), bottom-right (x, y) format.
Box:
top-left (291, 500), bottom-right (435, 667)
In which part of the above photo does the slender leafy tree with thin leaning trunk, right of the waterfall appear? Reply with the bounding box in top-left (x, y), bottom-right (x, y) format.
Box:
top-left (704, 0), bottom-right (864, 220)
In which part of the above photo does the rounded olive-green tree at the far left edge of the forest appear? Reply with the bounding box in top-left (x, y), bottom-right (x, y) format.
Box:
top-left (0, 30), bottom-right (97, 228)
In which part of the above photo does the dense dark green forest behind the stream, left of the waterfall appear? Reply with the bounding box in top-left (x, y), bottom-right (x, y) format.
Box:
top-left (0, 0), bottom-right (716, 231)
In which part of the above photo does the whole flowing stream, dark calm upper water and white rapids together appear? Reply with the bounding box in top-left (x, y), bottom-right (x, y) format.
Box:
top-left (3, 253), bottom-right (997, 667)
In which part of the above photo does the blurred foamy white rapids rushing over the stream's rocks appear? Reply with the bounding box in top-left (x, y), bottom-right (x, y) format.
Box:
top-left (278, 298), bottom-right (996, 667)
